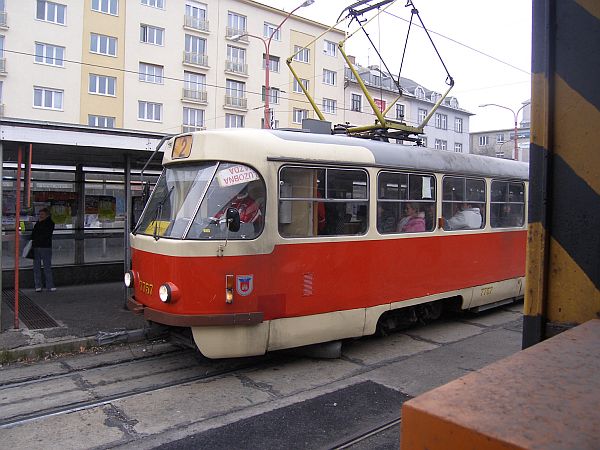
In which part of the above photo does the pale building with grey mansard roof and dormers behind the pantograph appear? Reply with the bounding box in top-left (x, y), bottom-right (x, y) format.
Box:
top-left (343, 58), bottom-right (473, 153)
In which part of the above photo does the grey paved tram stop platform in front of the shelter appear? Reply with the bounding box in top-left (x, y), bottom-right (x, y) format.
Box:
top-left (0, 282), bottom-right (146, 364)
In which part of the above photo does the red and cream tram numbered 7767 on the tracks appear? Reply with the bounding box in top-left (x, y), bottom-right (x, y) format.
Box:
top-left (125, 129), bottom-right (528, 358)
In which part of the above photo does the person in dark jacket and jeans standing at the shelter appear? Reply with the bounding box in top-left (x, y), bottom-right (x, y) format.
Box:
top-left (31, 208), bottom-right (56, 292)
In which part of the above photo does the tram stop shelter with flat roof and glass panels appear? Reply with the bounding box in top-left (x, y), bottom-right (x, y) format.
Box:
top-left (0, 118), bottom-right (165, 297)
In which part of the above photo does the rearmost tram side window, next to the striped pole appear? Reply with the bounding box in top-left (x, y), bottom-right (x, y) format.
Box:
top-left (490, 180), bottom-right (525, 228)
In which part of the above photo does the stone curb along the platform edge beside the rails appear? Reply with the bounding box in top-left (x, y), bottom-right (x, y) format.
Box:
top-left (0, 329), bottom-right (148, 364)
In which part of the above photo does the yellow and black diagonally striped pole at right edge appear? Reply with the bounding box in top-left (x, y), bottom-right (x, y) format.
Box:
top-left (523, 0), bottom-right (600, 348)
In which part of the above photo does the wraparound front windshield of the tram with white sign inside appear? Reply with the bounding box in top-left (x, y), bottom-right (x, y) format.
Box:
top-left (134, 162), bottom-right (265, 239)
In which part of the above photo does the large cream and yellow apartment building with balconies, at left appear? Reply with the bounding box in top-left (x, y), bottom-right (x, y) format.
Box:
top-left (0, 0), bottom-right (344, 133)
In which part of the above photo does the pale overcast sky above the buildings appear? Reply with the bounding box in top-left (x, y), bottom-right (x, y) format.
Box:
top-left (258, 0), bottom-right (532, 132)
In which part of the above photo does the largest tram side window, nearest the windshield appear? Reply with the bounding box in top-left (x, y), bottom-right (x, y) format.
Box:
top-left (279, 166), bottom-right (369, 237)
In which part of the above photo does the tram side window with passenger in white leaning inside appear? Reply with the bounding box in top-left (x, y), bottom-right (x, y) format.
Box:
top-left (442, 177), bottom-right (485, 230)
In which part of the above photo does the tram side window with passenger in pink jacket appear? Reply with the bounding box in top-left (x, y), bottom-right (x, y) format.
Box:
top-left (377, 172), bottom-right (435, 234)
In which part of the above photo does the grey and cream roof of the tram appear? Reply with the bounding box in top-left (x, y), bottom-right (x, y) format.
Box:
top-left (180, 129), bottom-right (529, 180)
